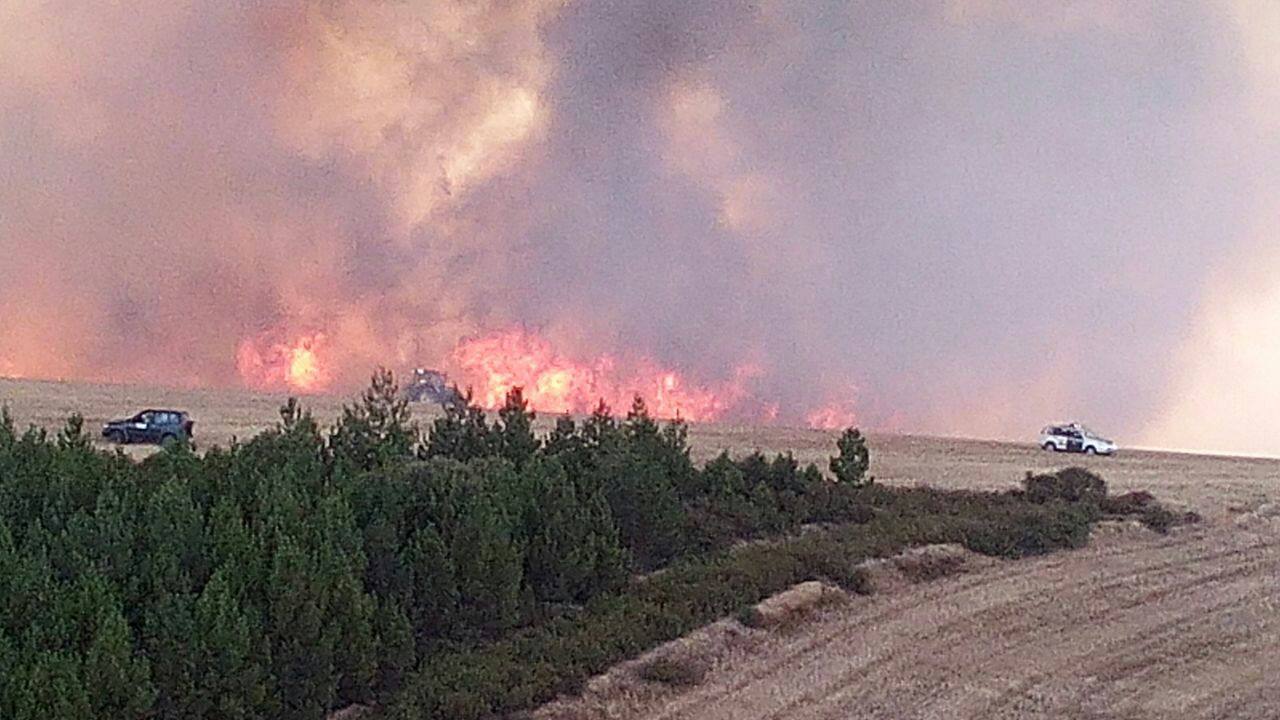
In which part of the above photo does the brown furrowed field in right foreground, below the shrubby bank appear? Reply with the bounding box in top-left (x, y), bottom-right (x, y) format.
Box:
top-left (586, 520), bottom-right (1280, 720)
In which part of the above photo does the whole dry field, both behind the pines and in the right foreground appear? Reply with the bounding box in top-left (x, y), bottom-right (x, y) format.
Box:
top-left (0, 371), bottom-right (1280, 720)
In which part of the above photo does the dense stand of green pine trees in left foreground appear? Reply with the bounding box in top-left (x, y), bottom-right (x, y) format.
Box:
top-left (0, 373), bottom-right (867, 720)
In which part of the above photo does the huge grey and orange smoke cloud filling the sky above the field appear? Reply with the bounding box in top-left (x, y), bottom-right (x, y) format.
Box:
top-left (0, 0), bottom-right (1280, 452)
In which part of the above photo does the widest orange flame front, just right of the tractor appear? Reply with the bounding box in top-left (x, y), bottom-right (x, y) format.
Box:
top-left (451, 329), bottom-right (759, 421)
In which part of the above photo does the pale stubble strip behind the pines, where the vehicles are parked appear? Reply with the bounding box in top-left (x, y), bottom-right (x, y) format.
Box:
top-left (0, 371), bottom-right (1280, 518)
